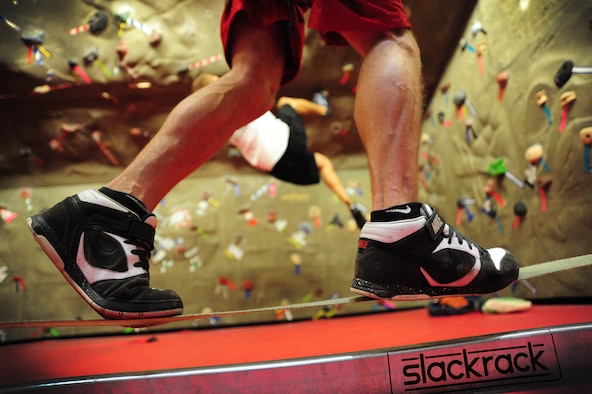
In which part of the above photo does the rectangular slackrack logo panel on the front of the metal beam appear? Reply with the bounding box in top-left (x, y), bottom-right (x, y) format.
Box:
top-left (391, 336), bottom-right (561, 392)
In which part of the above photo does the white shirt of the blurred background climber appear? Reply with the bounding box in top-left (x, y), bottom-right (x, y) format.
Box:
top-left (229, 111), bottom-right (290, 172)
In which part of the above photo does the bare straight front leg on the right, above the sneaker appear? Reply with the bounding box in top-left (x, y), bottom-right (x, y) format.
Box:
top-left (343, 30), bottom-right (423, 210)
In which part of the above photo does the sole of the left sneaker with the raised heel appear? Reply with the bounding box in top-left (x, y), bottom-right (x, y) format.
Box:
top-left (27, 217), bottom-right (183, 320)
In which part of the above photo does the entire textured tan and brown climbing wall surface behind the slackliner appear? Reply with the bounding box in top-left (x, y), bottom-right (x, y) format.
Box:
top-left (0, 0), bottom-right (592, 339)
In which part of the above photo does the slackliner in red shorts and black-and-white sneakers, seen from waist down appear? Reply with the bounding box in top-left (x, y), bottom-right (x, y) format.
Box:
top-left (28, 0), bottom-right (519, 319)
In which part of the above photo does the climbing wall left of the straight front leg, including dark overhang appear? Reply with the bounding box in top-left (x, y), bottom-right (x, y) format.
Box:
top-left (0, 0), bottom-right (382, 340)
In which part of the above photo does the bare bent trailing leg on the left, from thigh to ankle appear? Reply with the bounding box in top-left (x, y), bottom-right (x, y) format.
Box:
top-left (107, 16), bottom-right (284, 211)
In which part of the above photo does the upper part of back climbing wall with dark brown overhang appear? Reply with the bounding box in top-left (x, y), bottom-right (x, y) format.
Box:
top-left (0, 0), bottom-right (474, 186)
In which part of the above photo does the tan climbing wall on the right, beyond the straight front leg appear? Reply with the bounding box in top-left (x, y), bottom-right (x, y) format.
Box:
top-left (419, 0), bottom-right (592, 298)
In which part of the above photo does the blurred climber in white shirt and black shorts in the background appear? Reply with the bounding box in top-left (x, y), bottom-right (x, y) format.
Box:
top-left (191, 74), bottom-right (366, 229)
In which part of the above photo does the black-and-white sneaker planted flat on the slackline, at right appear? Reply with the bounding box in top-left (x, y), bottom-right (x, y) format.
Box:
top-left (351, 203), bottom-right (518, 301)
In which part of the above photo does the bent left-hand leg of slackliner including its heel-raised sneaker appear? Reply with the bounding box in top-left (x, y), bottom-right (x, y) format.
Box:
top-left (28, 13), bottom-right (286, 319)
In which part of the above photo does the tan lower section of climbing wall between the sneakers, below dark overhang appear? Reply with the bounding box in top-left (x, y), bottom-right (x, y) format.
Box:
top-left (0, 170), bottom-right (374, 340)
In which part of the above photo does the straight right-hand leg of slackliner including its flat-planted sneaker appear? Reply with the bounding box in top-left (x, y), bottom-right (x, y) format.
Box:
top-left (342, 29), bottom-right (518, 300)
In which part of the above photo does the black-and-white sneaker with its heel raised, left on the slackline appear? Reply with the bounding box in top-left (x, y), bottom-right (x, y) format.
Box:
top-left (27, 188), bottom-right (183, 319)
